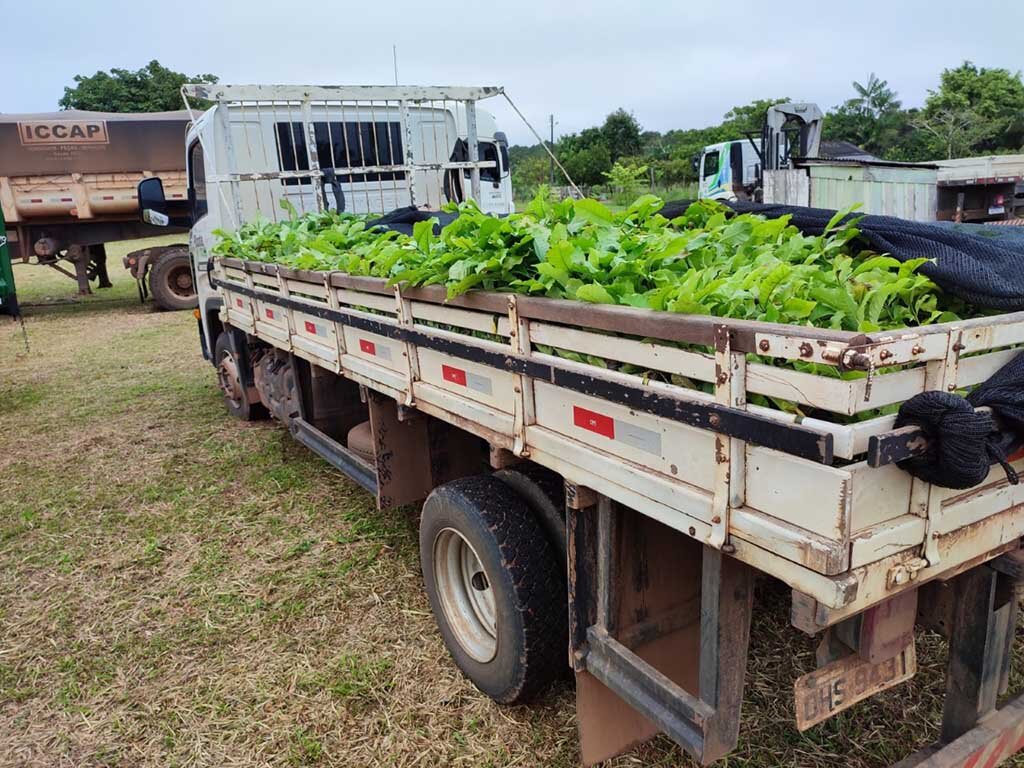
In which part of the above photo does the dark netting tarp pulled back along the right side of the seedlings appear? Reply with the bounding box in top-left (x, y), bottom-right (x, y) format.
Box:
top-left (663, 202), bottom-right (1024, 311)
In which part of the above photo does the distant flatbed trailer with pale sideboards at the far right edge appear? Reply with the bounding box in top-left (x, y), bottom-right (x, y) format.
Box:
top-left (935, 155), bottom-right (1024, 221)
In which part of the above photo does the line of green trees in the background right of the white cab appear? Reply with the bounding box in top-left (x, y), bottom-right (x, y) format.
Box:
top-left (510, 61), bottom-right (1024, 194)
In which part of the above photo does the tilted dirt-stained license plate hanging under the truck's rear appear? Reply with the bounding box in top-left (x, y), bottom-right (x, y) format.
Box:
top-left (793, 642), bottom-right (918, 731)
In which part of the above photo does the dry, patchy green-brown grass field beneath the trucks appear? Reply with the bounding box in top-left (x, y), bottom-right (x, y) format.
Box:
top-left (0, 248), bottom-right (1024, 768)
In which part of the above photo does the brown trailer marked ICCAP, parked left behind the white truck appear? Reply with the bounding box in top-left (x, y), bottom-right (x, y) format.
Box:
top-left (0, 110), bottom-right (196, 309)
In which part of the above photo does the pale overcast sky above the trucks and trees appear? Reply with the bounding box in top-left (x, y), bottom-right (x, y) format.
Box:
top-left (0, 0), bottom-right (1024, 145)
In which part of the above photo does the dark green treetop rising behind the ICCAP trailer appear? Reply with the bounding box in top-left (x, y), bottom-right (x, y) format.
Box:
top-left (58, 59), bottom-right (217, 112)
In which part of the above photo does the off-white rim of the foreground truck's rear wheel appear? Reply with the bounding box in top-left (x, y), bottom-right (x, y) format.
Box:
top-left (433, 528), bottom-right (498, 663)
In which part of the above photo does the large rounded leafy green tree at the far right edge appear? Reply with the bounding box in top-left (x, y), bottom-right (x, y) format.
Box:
top-left (919, 61), bottom-right (1024, 155)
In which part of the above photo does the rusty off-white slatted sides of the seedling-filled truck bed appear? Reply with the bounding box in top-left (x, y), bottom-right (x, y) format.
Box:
top-left (211, 259), bottom-right (1024, 624)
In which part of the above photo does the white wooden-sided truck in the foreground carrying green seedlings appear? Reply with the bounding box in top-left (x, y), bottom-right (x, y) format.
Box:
top-left (139, 85), bottom-right (1024, 767)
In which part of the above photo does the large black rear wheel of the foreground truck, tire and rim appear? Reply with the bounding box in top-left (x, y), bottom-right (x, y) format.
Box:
top-left (420, 475), bottom-right (568, 703)
